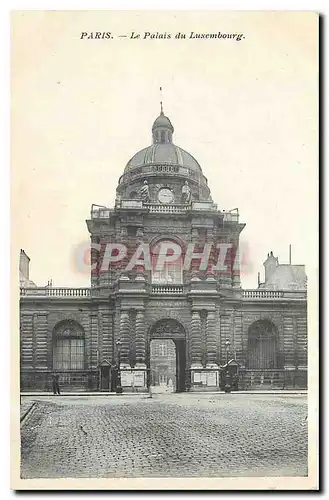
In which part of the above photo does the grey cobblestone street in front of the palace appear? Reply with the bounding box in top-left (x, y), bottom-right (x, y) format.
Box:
top-left (21, 393), bottom-right (307, 479)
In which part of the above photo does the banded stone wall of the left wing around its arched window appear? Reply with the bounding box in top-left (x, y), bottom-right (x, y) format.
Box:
top-left (20, 299), bottom-right (114, 391)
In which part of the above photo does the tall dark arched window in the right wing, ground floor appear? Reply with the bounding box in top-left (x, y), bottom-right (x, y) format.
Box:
top-left (247, 320), bottom-right (278, 369)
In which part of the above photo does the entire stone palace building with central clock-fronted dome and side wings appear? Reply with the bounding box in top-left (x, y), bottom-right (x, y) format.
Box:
top-left (20, 106), bottom-right (307, 392)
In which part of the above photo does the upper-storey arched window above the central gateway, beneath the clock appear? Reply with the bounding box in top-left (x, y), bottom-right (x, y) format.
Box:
top-left (151, 240), bottom-right (183, 285)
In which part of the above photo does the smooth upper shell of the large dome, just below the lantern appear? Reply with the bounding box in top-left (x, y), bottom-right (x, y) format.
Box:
top-left (125, 142), bottom-right (201, 172)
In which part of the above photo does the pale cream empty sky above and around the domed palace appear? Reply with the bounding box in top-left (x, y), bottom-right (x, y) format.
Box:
top-left (11, 11), bottom-right (318, 288)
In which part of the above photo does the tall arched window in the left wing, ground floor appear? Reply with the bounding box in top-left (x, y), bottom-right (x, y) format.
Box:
top-left (53, 321), bottom-right (85, 371)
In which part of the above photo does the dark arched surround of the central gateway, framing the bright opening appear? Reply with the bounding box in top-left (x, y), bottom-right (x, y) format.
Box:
top-left (147, 319), bottom-right (186, 392)
